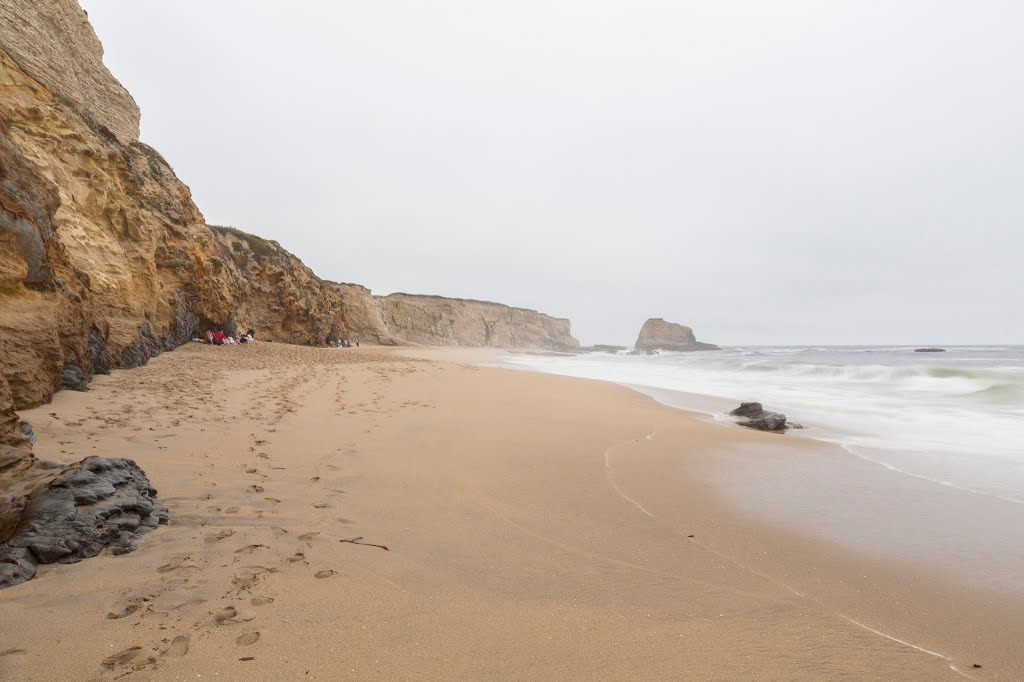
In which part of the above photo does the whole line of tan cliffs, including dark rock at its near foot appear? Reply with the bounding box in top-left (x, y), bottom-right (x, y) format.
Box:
top-left (0, 0), bottom-right (579, 585)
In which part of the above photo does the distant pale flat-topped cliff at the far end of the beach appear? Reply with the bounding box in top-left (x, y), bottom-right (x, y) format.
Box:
top-left (377, 294), bottom-right (580, 350)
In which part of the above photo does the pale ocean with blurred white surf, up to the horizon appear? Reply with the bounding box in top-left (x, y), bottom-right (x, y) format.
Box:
top-left (508, 346), bottom-right (1024, 504)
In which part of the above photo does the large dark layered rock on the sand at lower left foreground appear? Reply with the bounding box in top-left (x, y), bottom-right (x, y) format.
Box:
top-left (0, 457), bottom-right (169, 588)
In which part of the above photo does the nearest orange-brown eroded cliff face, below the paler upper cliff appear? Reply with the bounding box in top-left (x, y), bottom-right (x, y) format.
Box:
top-left (0, 43), bottom-right (230, 408)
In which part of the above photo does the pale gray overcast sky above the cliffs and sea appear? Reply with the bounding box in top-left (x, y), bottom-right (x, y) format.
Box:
top-left (83, 0), bottom-right (1024, 344)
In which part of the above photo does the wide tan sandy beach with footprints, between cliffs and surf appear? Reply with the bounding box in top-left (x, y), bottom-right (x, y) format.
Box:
top-left (0, 343), bottom-right (1024, 680)
